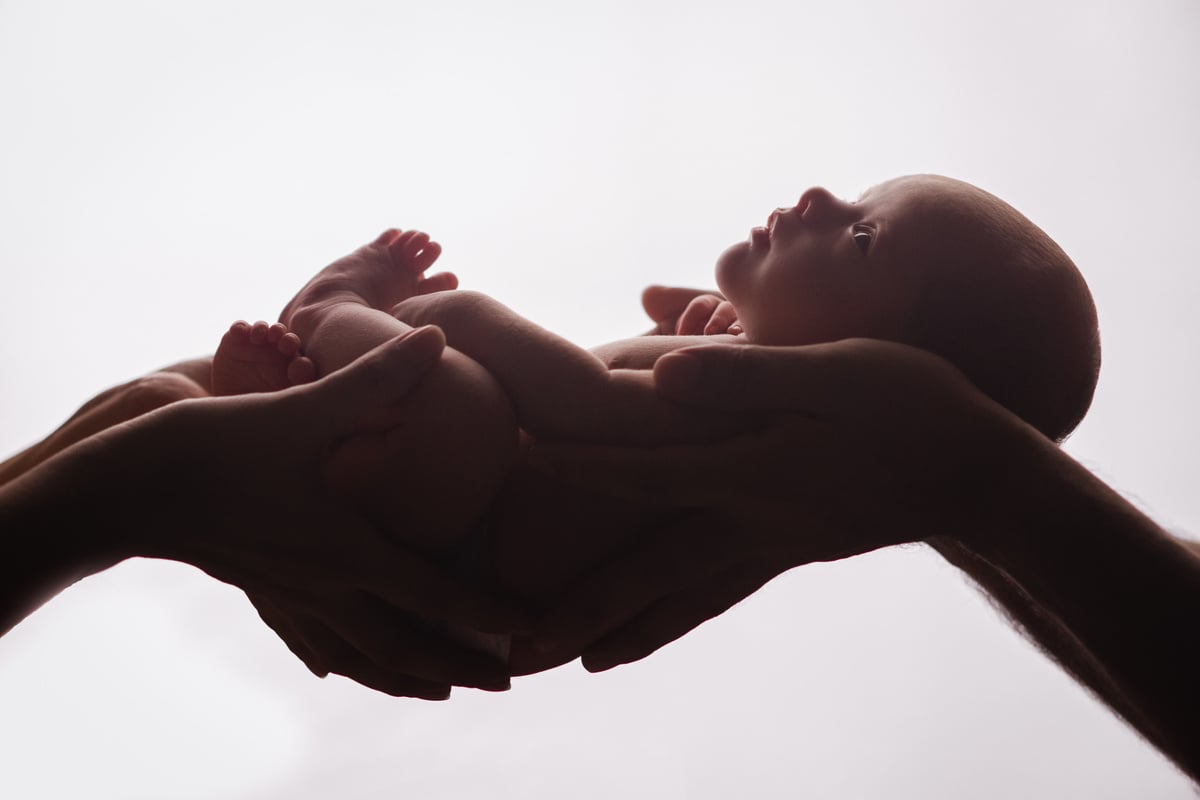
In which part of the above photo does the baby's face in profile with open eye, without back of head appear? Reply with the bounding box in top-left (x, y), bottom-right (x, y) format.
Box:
top-left (716, 176), bottom-right (961, 344)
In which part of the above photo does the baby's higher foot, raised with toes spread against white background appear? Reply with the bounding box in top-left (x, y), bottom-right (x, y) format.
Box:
top-left (280, 228), bottom-right (458, 337)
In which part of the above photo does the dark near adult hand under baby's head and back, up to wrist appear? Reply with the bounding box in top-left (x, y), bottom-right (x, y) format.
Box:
top-left (535, 339), bottom-right (1054, 670)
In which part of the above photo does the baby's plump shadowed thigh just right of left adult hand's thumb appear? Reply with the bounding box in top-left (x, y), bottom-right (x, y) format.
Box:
top-left (330, 349), bottom-right (517, 555)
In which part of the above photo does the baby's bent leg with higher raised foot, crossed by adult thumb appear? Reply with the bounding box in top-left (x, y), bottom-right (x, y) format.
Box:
top-left (281, 230), bottom-right (517, 553)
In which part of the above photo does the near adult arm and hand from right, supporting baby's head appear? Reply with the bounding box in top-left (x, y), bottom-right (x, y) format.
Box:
top-left (540, 341), bottom-right (1200, 777)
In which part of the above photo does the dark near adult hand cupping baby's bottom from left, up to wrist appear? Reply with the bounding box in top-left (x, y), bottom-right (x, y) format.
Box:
top-left (113, 329), bottom-right (528, 699)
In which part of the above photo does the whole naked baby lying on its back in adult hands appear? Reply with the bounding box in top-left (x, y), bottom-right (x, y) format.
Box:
top-left (212, 175), bottom-right (1099, 673)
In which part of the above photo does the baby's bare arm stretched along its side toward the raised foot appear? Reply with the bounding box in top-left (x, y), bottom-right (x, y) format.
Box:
top-left (394, 291), bottom-right (745, 444)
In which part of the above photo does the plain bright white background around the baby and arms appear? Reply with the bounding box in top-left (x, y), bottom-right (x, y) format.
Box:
top-left (0, 0), bottom-right (1200, 800)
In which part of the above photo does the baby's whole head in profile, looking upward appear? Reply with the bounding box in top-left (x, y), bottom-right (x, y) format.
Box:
top-left (716, 175), bottom-right (1100, 440)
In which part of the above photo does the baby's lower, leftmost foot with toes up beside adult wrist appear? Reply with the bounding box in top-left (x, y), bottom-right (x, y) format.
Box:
top-left (212, 320), bottom-right (316, 395)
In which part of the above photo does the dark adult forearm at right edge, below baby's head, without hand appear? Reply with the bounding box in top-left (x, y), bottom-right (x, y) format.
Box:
top-left (955, 455), bottom-right (1200, 777)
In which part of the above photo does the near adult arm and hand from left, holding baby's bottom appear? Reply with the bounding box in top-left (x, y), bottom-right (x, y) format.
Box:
top-left (0, 329), bottom-right (522, 698)
